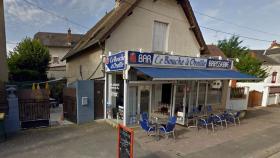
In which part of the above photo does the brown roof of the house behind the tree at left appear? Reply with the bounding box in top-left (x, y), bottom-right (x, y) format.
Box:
top-left (34, 32), bottom-right (83, 47)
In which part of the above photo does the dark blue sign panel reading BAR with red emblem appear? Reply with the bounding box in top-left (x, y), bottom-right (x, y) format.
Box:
top-left (128, 51), bottom-right (154, 65)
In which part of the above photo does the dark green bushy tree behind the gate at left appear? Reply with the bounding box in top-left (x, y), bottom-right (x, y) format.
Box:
top-left (8, 37), bottom-right (51, 81)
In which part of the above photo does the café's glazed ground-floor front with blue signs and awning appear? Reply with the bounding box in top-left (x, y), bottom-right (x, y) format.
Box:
top-left (104, 51), bottom-right (256, 126)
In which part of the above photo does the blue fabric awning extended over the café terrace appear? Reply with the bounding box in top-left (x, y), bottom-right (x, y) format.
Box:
top-left (135, 67), bottom-right (259, 80)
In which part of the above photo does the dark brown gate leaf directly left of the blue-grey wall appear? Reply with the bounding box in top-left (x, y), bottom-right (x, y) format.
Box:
top-left (63, 88), bottom-right (77, 123)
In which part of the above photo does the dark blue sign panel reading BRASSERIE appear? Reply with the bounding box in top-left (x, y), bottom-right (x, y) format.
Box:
top-left (207, 59), bottom-right (232, 69)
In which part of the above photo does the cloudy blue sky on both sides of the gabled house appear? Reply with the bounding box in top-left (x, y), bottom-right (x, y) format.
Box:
top-left (4, 0), bottom-right (280, 51)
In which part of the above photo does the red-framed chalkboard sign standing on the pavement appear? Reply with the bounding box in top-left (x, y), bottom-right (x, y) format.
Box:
top-left (118, 125), bottom-right (134, 158)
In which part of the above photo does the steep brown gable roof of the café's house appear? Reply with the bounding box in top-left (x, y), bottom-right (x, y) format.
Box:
top-left (62, 0), bottom-right (207, 60)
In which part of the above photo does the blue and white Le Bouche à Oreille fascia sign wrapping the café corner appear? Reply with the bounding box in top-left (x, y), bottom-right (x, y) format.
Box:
top-left (106, 51), bottom-right (232, 71)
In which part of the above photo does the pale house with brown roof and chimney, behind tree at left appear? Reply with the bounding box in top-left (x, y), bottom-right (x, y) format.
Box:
top-left (34, 29), bottom-right (83, 79)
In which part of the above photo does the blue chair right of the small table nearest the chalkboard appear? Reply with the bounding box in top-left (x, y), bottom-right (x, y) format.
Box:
top-left (159, 116), bottom-right (177, 139)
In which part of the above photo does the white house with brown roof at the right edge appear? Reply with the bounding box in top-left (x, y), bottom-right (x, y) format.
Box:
top-left (237, 41), bottom-right (280, 106)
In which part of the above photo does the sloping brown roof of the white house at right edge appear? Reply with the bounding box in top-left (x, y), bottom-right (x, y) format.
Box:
top-left (250, 50), bottom-right (280, 65)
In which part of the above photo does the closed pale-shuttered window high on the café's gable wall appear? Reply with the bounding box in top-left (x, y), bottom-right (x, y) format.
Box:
top-left (153, 21), bottom-right (168, 52)
